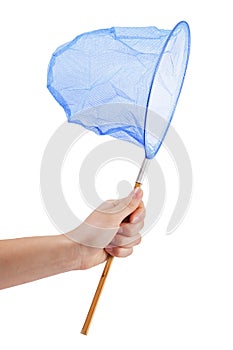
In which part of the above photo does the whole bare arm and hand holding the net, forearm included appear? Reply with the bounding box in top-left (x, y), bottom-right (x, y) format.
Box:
top-left (0, 189), bottom-right (145, 289)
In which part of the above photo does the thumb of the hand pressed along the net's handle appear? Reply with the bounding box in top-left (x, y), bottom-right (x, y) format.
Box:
top-left (115, 187), bottom-right (143, 221)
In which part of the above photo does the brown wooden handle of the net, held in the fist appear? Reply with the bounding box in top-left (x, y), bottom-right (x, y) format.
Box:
top-left (81, 182), bottom-right (141, 335)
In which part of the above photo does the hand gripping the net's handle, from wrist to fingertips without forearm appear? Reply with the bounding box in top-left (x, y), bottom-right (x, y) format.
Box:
top-left (66, 188), bottom-right (145, 269)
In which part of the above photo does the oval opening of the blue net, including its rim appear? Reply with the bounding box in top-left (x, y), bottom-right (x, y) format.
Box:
top-left (144, 21), bottom-right (190, 159)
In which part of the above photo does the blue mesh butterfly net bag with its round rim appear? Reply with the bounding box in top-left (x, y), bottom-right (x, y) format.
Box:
top-left (47, 22), bottom-right (190, 159)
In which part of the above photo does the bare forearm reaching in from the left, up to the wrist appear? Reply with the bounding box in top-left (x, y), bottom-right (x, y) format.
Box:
top-left (0, 235), bottom-right (81, 289)
